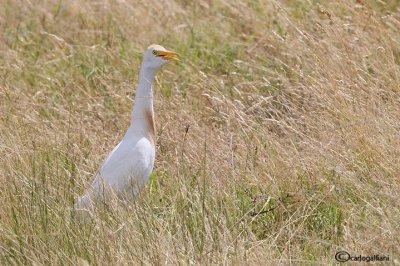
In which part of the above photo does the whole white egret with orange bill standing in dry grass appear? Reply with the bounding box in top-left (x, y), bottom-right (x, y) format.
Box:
top-left (75, 45), bottom-right (176, 209)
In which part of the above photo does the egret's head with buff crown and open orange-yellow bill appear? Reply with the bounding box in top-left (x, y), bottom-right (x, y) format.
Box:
top-left (143, 44), bottom-right (178, 71)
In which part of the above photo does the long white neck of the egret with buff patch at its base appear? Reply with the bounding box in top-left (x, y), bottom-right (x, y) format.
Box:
top-left (131, 66), bottom-right (155, 145)
